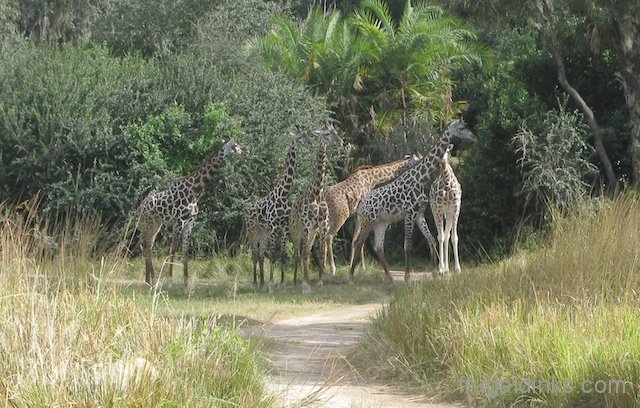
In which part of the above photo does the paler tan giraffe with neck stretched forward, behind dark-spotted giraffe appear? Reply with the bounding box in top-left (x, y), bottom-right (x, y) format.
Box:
top-left (321, 154), bottom-right (420, 275)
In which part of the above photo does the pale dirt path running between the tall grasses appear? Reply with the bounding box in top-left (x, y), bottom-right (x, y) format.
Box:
top-left (245, 272), bottom-right (459, 408)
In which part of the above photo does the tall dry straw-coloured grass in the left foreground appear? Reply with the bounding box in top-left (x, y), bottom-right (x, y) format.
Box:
top-left (0, 208), bottom-right (273, 407)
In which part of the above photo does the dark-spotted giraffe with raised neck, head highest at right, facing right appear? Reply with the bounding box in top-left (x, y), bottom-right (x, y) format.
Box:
top-left (349, 118), bottom-right (475, 282)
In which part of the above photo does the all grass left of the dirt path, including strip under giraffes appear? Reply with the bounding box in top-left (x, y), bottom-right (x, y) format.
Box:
top-left (0, 204), bottom-right (393, 407)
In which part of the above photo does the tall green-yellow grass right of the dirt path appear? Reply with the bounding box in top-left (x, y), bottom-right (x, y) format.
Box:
top-left (353, 196), bottom-right (640, 407)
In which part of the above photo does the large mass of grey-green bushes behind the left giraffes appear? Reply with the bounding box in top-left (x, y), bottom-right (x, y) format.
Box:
top-left (0, 0), bottom-right (327, 252)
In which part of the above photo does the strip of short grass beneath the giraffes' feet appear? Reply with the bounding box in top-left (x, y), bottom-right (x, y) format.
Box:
top-left (112, 250), bottom-right (395, 324)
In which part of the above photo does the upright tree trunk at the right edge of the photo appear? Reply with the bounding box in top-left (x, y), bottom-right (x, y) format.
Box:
top-left (616, 16), bottom-right (640, 190)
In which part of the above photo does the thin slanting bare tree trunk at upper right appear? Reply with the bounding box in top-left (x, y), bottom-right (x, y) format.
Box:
top-left (541, 0), bottom-right (620, 194)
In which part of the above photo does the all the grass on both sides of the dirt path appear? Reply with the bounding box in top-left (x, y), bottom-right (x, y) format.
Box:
top-left (10, 197), bottom-right (640, 407)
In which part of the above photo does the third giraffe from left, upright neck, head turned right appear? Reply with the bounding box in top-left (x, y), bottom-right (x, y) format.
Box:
top-left (289, 127), bottom-right (342, 293)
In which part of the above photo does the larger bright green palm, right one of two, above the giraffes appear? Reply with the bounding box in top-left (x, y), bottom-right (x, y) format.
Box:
top-left (352, 0), bottom-right (489, 128)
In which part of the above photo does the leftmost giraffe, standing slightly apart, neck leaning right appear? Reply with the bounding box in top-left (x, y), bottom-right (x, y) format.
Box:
top-left (138, 139), bottom-right (248, 287)
